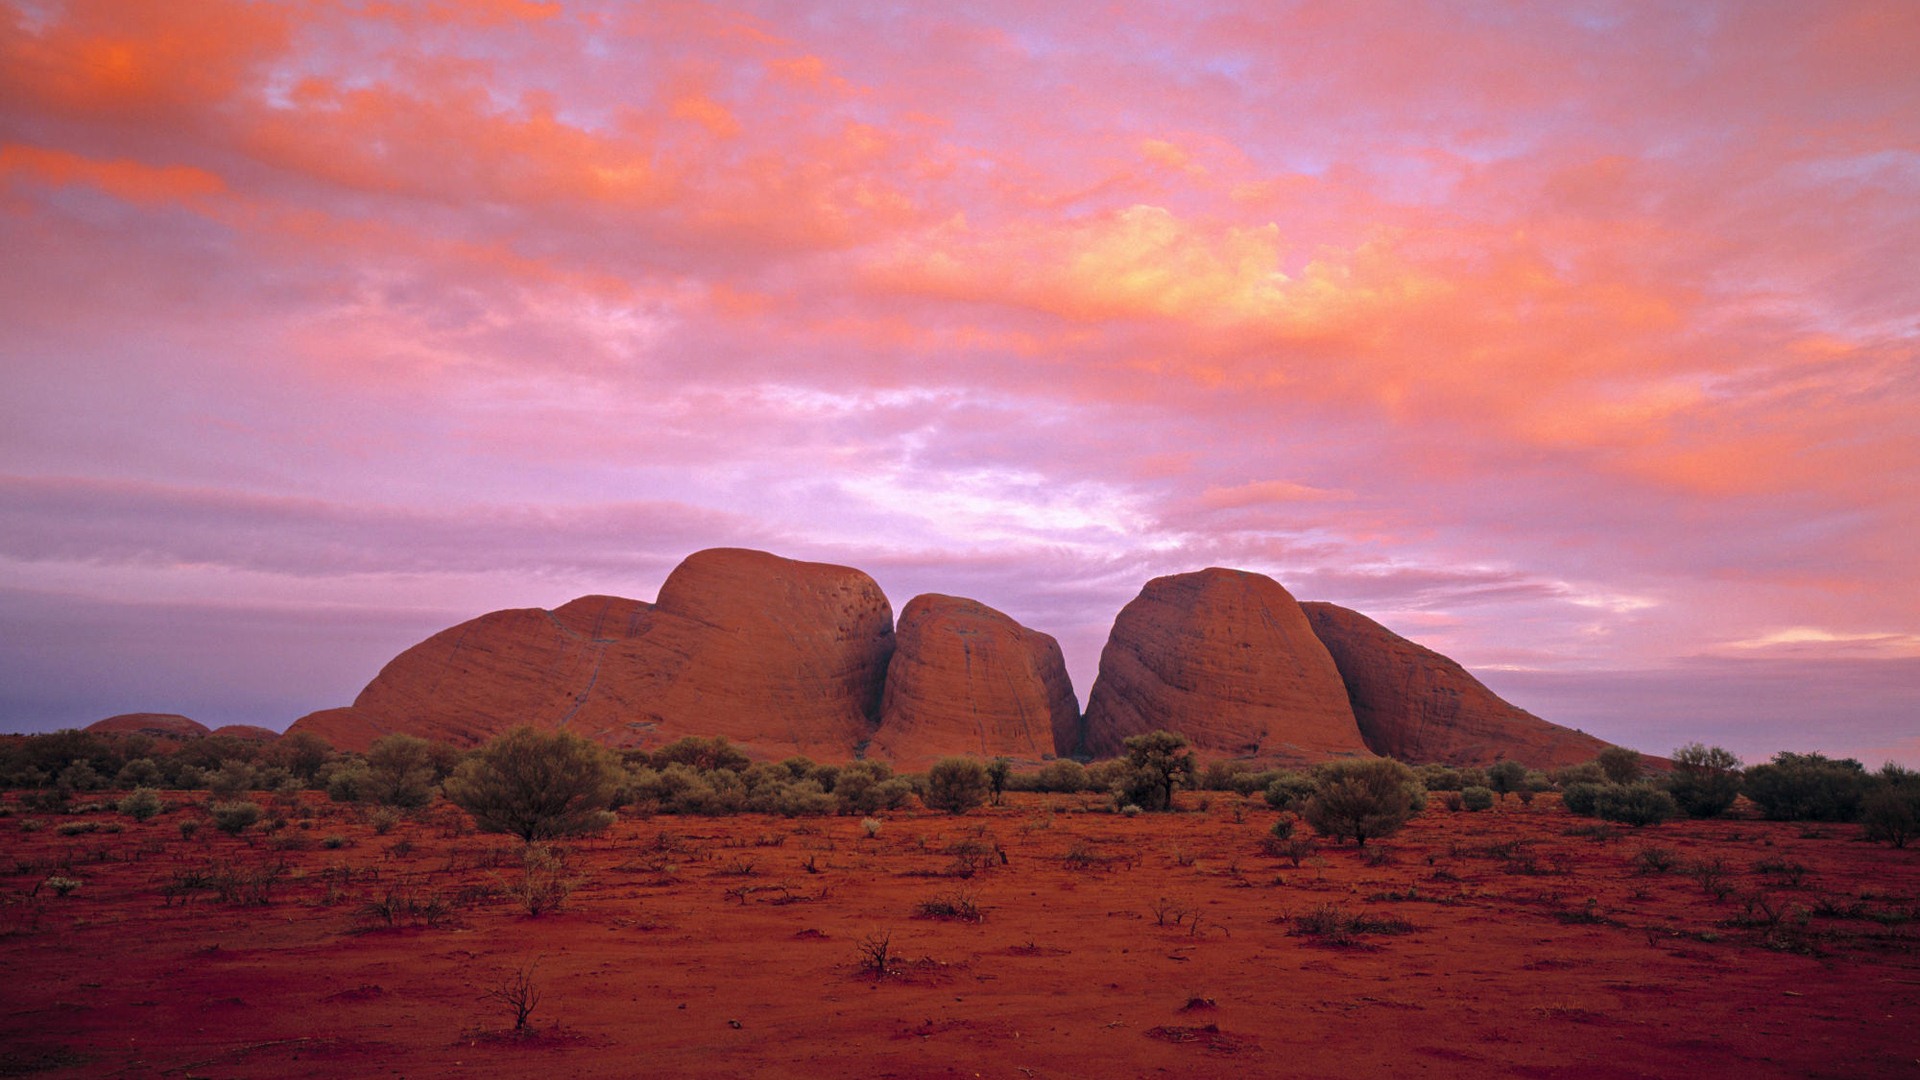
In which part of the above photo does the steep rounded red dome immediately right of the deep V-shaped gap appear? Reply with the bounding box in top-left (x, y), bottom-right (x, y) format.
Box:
top-left (1085, 567), bottom-right (1369, 765)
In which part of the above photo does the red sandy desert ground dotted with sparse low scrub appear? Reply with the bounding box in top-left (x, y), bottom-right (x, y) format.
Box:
top-left (0, 792), bottom-right (1920, 1078)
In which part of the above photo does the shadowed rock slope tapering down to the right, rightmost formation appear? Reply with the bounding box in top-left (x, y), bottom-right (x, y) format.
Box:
top-left (1300, 601), bottom-right (1607, 769)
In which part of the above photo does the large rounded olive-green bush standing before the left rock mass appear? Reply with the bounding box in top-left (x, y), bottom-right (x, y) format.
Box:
top-left (445, 726), bottom-right (622, 842)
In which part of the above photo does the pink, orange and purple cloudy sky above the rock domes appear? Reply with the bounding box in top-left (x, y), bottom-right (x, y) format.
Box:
top-left (0, 0), bottom-right (1920, 765)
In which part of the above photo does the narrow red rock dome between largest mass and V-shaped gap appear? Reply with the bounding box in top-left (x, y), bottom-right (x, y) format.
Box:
top-left (868, 594), bottom-right (1079, 771)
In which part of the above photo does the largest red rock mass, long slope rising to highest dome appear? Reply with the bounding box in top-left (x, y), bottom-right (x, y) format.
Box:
top-left (288, 548), bottom-right (893, 761)
